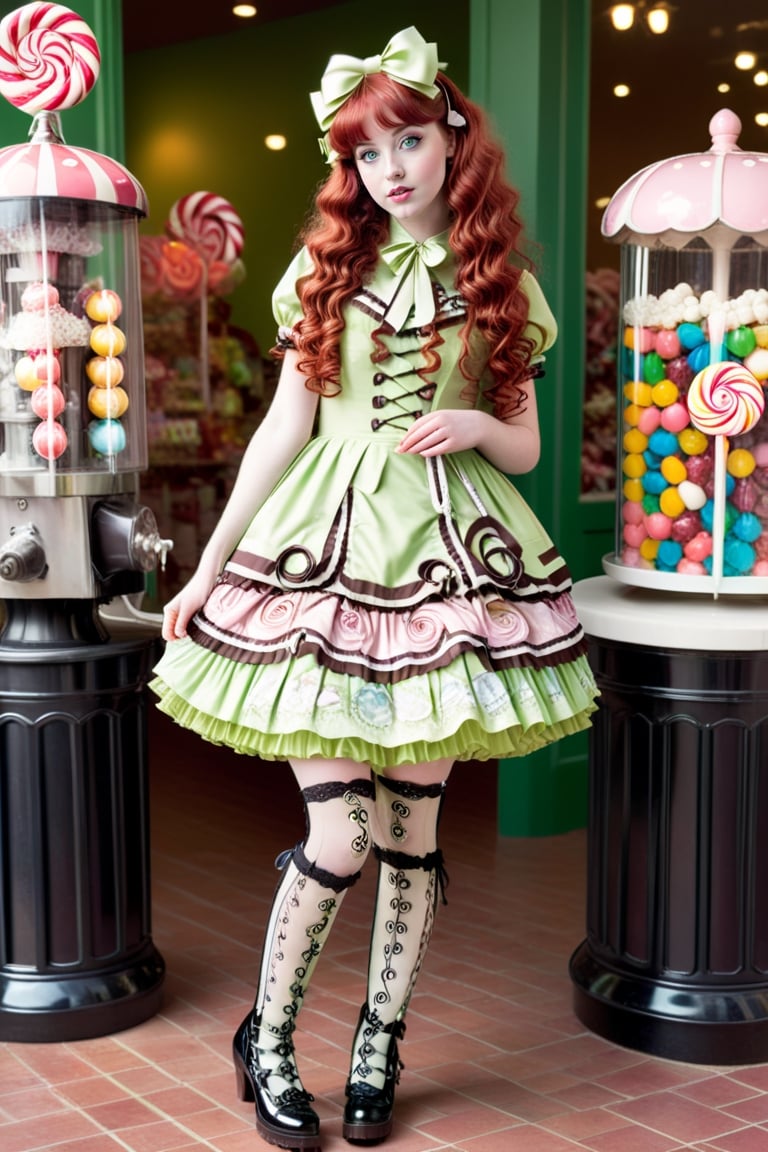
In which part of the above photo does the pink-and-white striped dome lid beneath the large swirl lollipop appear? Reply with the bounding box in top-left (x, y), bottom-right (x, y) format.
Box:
top-left (0, 112), bottom-right (149, 215)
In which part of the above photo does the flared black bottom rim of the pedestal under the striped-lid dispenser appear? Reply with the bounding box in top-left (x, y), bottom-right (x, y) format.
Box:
top-left (0, 943), bottom-right (165, 1044)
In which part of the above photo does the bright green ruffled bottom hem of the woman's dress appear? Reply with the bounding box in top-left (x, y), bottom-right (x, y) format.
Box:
top-left (150, 679), bottom-right (596, 772)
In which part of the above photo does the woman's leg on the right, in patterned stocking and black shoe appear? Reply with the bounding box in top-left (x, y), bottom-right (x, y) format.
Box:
top-left (343, 778), bottom-right (447, 1143)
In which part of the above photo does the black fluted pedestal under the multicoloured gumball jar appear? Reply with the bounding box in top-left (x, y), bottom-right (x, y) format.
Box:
top-left (570, 637), bottom-right (768, 1064)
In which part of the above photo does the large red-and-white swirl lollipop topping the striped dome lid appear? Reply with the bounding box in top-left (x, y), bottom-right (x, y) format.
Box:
top-left (0, 3), bottom-right (101, 113)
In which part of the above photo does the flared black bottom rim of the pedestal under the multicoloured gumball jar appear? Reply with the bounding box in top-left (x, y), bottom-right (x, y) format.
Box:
top-left (569, 941), bottom-right (768, 1064)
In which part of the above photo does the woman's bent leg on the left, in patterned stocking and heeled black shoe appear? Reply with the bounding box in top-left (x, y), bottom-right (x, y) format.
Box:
top-left (234, 768), bottom-right (373, 1149)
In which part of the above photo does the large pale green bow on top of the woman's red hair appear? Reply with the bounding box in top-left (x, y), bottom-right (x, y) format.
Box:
top-left (310, 28), bottom-right (444, 132)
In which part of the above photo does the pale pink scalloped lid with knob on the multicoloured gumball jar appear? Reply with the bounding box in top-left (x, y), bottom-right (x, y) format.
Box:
top-left (601, 108), bottom-right (768, 248)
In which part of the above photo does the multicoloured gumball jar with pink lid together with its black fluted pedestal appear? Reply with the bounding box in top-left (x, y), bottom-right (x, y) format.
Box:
top-left (570, 109), bottom-right (768, 1064)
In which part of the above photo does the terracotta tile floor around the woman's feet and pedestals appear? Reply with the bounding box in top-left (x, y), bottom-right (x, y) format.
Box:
top-left (0, 708), bottom-right (768, 1152)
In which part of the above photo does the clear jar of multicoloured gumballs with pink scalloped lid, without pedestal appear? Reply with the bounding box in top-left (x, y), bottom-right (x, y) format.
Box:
top-left (602, 109), bottom-right (768, 596)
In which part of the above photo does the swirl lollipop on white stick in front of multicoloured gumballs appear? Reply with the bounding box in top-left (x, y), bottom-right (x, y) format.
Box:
top-left (687, 361), bottom-right (766, 597)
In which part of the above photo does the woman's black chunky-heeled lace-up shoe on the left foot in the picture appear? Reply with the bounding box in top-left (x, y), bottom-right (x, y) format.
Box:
top-left (233, 1013), bottom-right (320, 1152)
